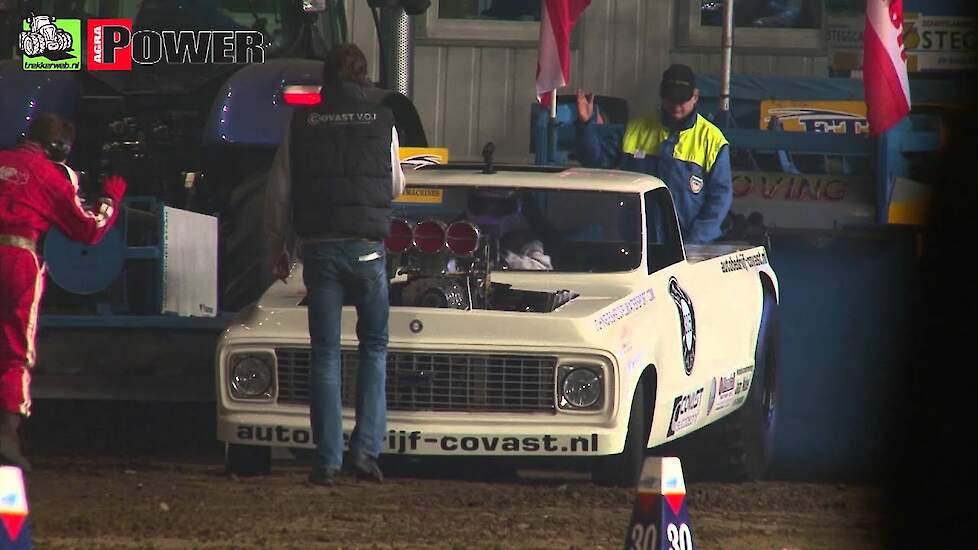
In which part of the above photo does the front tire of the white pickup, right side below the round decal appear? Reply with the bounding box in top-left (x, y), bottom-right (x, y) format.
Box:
top-left (591, 383), bottom-right (652, 487)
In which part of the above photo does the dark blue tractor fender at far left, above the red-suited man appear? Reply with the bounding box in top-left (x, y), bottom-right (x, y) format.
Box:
top-left (0, 59), bottom-right (78, 149)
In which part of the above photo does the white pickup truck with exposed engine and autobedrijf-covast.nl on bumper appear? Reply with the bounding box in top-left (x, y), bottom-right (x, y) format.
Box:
top-left (216, 165), bottom-right (778, 485)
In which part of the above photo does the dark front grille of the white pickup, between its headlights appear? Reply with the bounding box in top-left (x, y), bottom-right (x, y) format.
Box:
top-left (275, 348), bottom-right (557, 412)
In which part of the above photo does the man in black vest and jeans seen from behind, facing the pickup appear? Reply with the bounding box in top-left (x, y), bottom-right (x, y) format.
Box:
top-left (266, 44), bottom-right (404, 485)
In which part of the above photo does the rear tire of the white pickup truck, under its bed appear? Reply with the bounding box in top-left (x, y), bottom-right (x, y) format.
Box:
top-left (690, 293), bottom-right (781, 482)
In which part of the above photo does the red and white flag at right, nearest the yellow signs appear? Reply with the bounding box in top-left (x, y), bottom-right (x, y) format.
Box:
top-left (863, 0), bottom-right (910, 135)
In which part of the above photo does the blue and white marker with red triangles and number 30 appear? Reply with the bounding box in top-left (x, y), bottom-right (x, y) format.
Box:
top-left (625, 456), bottom-right (695, 550)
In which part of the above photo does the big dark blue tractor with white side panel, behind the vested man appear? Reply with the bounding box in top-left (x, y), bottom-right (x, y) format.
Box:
top-left (0, 0), bottom-right (427, 401)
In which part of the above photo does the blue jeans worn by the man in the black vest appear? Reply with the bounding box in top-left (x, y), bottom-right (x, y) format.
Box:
top-left (302, 240), bottom-right (390, 470)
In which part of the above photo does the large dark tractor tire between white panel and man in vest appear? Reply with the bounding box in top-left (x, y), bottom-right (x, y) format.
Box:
top-left (220, 171), bottom-right (272, 311)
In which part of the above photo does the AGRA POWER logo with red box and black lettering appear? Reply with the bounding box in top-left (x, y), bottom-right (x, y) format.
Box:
top-left (87, 19), bottom-right (265, 71)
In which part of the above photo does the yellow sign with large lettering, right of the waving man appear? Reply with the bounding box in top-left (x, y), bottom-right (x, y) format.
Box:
top-left (760, 99), bottom-right (869, 134)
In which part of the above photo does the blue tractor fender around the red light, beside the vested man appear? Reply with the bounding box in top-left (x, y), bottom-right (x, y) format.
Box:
top-left (201, 59), bottom-right (323, 147)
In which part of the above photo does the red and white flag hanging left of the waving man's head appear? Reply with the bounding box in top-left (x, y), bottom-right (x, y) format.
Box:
top-left (537, 0), bottom-right (591, 105)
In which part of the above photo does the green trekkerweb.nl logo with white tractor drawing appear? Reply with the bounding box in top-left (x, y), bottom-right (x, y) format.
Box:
top-left (17, 14), bottom-right (81, 71)
